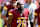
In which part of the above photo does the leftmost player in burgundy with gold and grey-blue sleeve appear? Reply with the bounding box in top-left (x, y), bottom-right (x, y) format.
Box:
top-left (1, 2), bottom-right (15, 25)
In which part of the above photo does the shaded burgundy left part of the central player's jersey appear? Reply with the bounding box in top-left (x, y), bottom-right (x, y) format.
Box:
top-left (9, 9), bottom-right (29, 27)
